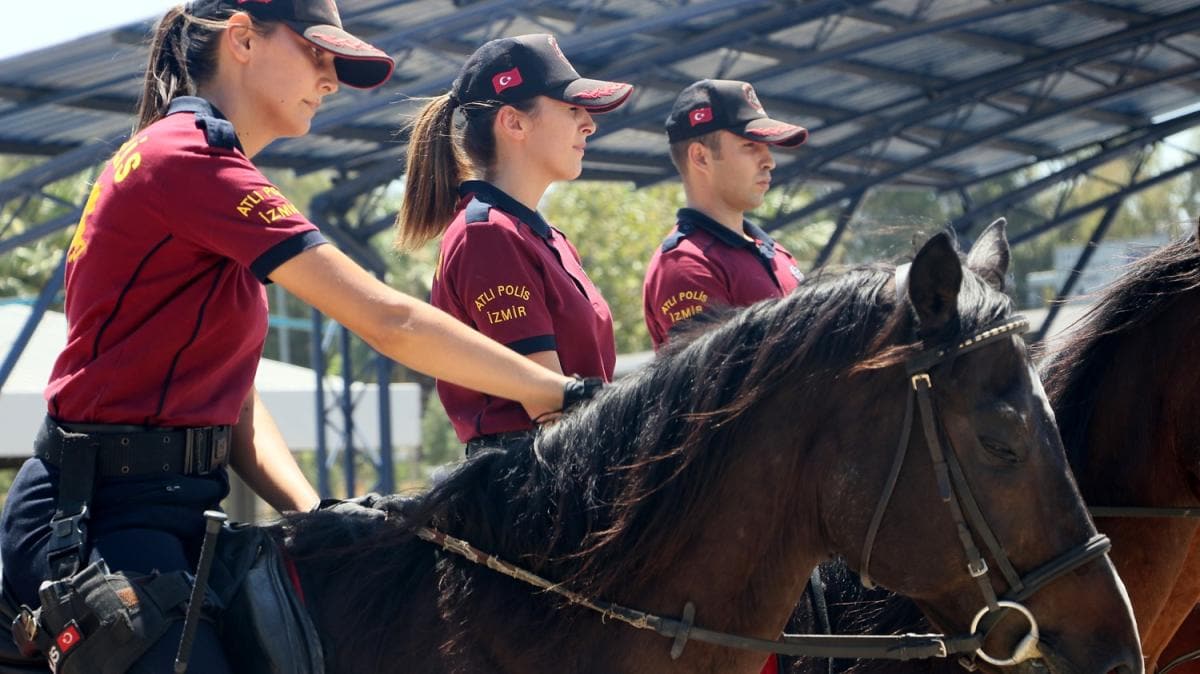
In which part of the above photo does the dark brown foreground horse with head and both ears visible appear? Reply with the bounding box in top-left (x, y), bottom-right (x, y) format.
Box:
top-left (277, 229), bottom-right (1141, 674)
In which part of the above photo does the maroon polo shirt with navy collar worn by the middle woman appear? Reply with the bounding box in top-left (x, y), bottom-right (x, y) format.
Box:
top-left (432, 180), bottom-right (617, 443)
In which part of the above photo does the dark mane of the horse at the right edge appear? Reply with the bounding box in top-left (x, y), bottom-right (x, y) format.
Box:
top-left (1040, 236), bottom-right (1200, 465)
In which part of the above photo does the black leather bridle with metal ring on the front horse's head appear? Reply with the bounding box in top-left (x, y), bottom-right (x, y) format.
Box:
top-left (859, 317), bottom-right (1111, 667)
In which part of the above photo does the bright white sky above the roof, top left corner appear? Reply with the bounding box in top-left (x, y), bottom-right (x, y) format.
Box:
top-left (0, 0), bottom-right (185, 59)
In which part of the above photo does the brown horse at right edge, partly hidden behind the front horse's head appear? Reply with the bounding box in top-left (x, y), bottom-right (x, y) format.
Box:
top-left (791, 221), bottom-right (1200, 674)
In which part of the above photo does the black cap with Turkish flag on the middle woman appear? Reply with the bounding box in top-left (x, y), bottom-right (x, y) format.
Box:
top-left (450, 34), bottom-right (634, 113)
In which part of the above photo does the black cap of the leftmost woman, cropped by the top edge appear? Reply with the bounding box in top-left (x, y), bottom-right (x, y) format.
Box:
top-left (188, 0), bottom-right (396, 89)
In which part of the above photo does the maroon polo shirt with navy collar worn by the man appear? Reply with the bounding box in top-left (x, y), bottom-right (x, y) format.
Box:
top-left (642, 209), bottom-right (804, 349)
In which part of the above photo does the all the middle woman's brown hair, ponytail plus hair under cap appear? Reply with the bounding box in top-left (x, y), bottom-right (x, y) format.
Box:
top-left (396, 94), bottom-right (538, 251)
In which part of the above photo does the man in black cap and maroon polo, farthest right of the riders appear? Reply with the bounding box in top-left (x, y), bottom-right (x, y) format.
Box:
top-left (642, 79), bottom-right (809, 349)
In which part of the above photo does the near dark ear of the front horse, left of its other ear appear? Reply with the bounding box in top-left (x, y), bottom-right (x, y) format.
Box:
top-left (908, 231), bottom-right (962, 332)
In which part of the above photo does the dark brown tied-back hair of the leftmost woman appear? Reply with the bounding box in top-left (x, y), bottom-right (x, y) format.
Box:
top-left (133, 5), bottom-right (275, 133)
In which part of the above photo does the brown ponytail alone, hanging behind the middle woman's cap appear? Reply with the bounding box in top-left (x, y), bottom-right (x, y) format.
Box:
top-left (396, 94), bottom-right (470, 251)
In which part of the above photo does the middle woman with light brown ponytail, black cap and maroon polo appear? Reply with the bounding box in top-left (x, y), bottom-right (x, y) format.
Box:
top-left (397, 34), bottom-right (632, 453)
